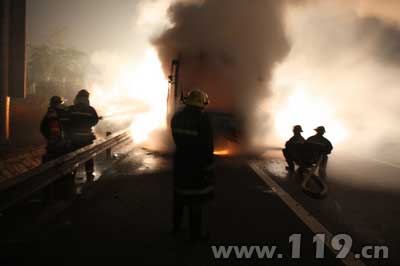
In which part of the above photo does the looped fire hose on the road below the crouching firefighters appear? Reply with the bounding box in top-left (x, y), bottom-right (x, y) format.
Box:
top-left (301, 156), bottom-right (328, 199)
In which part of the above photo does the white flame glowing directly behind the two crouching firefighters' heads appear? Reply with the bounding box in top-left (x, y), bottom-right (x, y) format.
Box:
top-left (275, 87), bottom-right (348, 143)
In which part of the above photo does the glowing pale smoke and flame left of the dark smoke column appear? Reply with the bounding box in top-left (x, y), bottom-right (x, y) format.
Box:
top-left (28, 0), bottom-right (173, 148)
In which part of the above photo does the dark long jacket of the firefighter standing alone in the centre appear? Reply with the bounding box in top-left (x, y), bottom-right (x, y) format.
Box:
top-left (171, 106), bottom-right (214, 196)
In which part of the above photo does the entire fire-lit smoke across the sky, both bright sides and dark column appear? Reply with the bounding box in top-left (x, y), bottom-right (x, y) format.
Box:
top-left (28, 0), bottom-right (400, 163)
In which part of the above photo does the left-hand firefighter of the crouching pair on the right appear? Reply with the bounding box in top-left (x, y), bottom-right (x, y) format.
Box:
top-left (282, 125), bottom-right (305, 172)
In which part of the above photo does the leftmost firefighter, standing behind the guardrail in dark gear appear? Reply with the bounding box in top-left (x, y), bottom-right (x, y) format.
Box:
top-left (40, 96), bottom-right (69, 162)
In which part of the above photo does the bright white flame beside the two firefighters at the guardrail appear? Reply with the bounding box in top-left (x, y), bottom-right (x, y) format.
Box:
top-left (91, 48), bottom-right (168, 144)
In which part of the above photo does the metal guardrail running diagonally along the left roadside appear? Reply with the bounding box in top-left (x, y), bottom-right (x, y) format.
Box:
top-left (0, 131), bottom-right (130, 212)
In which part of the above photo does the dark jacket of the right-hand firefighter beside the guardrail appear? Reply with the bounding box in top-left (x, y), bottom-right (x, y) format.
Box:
top-left (68, 103), bottom-right (99, 148)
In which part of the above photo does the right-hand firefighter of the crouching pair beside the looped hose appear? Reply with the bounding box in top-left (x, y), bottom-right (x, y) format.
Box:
top-left (306, 126), bottom-right (333, 178)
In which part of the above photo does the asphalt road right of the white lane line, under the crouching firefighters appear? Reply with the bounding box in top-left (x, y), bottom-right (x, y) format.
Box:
top-left (257, 149), bottom-right (400, 265)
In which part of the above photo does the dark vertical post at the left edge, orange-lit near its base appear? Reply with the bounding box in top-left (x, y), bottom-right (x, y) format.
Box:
top-left (0, 0), bottom-right (26, 144)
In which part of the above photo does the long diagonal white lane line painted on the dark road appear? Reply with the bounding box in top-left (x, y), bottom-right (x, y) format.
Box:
top-left (249, 162), bottom-right (365, 266)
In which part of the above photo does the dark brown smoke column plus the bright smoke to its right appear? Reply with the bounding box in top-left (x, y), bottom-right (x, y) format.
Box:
top-left (153, 0), bottom-right (400, 162)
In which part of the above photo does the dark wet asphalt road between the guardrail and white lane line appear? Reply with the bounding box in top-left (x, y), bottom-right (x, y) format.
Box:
top-left (0, 150), bottom-right (350, 265)
